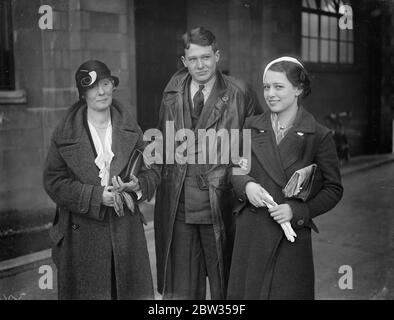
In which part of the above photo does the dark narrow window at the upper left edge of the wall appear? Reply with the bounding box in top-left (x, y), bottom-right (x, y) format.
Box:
top-left (0, 0), bottom-right (15, 90)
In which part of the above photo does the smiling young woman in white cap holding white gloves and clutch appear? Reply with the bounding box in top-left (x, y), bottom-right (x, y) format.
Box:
top-left (228, 57), bottom-right (343, 299)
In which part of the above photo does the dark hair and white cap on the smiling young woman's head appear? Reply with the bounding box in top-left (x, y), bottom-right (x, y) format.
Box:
top-left (268, 61), bottom-right (312, 99)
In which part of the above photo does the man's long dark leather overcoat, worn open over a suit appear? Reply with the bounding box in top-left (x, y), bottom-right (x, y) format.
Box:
top-left (154, 69), bottom-right (261, 296)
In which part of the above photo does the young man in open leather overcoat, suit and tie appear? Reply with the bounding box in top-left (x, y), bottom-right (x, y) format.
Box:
top-left (154, 27), bottom-right (261, 299)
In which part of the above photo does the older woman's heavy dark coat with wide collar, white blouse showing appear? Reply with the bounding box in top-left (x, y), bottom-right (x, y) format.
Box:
top-left (44, 101), bottom-right (160, 299)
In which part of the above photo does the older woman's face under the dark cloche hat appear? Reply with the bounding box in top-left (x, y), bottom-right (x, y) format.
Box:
top-left (85, 78), bottom-right (114, 111)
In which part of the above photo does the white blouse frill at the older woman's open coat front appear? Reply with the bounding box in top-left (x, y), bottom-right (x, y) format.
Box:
top-left (88, 121), bottom-right (114, 187)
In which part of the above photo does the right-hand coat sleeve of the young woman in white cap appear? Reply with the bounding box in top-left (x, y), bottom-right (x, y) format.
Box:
top-left (286, 132), bottom-right (343, 228)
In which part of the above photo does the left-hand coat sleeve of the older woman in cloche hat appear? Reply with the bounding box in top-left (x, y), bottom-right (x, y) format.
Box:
top-left (43, 127), bottom-right (106, 220)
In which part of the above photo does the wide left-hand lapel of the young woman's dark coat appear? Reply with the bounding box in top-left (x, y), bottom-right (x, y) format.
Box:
top-left (251, 112), bottom-right (287, 188)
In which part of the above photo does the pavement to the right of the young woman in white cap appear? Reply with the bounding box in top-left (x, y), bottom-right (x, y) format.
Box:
top-left (313, 162), bottom-right (394, 299)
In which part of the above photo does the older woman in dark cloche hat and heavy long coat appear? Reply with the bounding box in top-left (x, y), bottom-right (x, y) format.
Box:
top-left (44, 60), bottom-right (159, 299)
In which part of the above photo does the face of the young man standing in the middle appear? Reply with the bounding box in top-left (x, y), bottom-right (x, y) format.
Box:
top-left (182, 43), bottom-right (220, 84)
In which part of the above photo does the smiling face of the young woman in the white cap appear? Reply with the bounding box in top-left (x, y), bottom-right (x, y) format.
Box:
top-left (263, 70), bottom-right (302, 113)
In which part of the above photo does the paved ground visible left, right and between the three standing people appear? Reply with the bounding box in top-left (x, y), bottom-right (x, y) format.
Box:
top-left (0, 155), bottom-right (394, 300)
